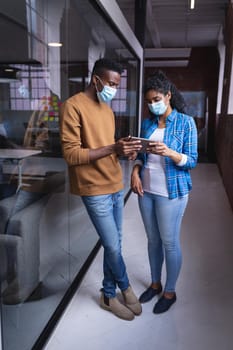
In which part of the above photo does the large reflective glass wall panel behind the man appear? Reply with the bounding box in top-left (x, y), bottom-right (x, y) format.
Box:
top-left (0, 0), bottom-right (139, 350)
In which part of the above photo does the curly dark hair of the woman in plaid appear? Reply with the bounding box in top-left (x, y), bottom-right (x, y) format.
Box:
top-left (144, 70), bottom-right (186, 113)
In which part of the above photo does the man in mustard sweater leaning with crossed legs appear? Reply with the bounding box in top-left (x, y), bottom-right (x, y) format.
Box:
top-left (60, 59), bottom-right (142, 320)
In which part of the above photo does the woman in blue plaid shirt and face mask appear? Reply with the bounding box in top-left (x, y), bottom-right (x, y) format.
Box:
top-left (131, 71), bottom-right (198, 314)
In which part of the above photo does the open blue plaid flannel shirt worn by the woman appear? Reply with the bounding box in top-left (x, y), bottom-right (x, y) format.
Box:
top-left (137, 109), bottom-right (198, 199)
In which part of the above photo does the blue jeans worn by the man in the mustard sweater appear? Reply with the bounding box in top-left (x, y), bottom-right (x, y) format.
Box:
top-left (82, 191), bottom-right (129, 298)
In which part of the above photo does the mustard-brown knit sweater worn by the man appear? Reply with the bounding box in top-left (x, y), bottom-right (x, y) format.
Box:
top-left (60, 92), bottom-right (123, 196)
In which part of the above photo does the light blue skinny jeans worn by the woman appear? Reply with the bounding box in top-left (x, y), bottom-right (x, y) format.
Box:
top-left (139, 192), bottom-right (188, 292)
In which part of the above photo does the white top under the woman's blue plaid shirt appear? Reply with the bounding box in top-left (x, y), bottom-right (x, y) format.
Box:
top-left (142, 128), bottom-right (168, 197)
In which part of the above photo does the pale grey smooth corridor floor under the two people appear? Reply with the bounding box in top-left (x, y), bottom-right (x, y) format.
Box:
top-left (45, 163), bottom-right (233, 350)
